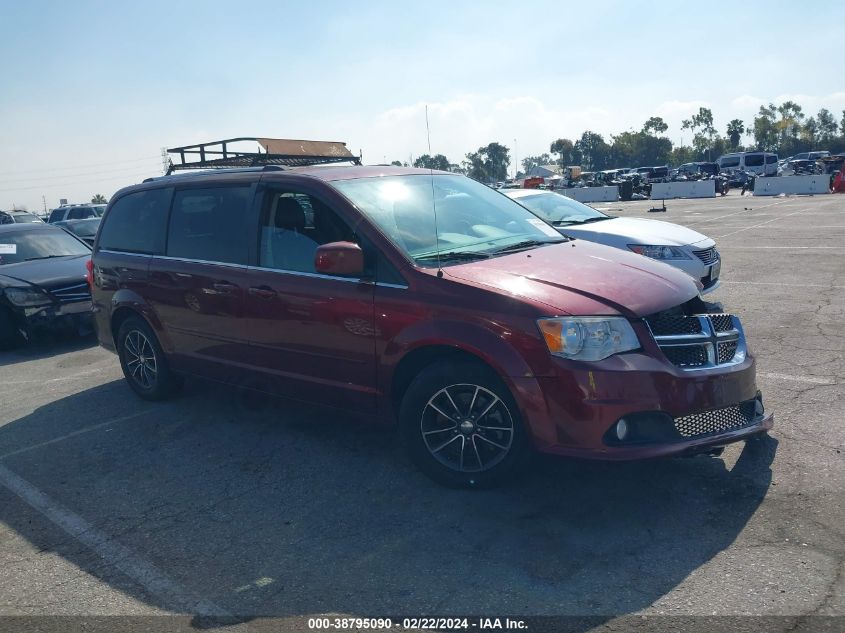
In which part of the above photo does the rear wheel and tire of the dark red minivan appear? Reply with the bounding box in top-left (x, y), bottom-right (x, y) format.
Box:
top-left (117, 317), bottom-right (182, 400)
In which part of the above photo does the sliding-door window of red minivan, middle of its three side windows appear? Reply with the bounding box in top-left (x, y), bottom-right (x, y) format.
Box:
top-left (167, 186), bottom-right (252, 265)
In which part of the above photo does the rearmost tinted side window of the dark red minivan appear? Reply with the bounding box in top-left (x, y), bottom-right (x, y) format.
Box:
top-left (98, 189), bottom-right (171, 254)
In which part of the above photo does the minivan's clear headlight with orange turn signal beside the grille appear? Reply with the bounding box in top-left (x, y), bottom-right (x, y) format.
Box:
top-left (537, 317), bottom-right (640, 360)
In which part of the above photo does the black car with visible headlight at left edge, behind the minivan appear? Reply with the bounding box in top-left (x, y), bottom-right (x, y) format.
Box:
top-left (0, 222), bottom-right (91, 348)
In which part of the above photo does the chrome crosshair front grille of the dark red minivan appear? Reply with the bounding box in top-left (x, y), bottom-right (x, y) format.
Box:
top-left (645, 311), bottom-right (746, 370)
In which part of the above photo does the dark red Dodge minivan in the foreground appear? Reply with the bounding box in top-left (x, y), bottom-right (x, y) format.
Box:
top-left (92, 166), bottom-right (772, 485)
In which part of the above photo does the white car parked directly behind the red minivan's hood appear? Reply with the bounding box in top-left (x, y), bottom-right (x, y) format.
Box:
top-left (505, 189), bottom-right (722, 294)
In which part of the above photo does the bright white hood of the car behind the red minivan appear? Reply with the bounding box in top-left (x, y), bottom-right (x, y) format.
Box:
top-left (559, 218), bottom-right (710, 246)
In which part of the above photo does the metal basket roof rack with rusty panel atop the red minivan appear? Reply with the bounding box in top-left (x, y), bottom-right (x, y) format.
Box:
top-left (167, 136), bottom-right (361, 175)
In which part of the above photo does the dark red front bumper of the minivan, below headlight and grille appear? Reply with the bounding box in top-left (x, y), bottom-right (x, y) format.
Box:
top-left (517, 352), bottom-right (774, 460)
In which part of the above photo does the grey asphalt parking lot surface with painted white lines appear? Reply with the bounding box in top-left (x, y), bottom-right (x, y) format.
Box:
top-left (0, 192), bottom-right (845, 630)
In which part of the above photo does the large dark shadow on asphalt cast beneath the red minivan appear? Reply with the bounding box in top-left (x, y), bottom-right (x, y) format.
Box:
top-left (0, 381), bottom-right (777, 625)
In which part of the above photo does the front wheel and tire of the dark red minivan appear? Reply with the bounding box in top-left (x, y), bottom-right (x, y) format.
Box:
top-left (399, 361), bottom-right (530, 488)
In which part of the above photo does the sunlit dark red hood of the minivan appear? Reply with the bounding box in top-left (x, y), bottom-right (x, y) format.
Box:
top-left (443, 240), bottom-right (700, 317)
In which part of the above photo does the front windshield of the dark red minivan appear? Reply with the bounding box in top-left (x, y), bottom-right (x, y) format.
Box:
top-left (332, 174), bottom-right (566, 266)
